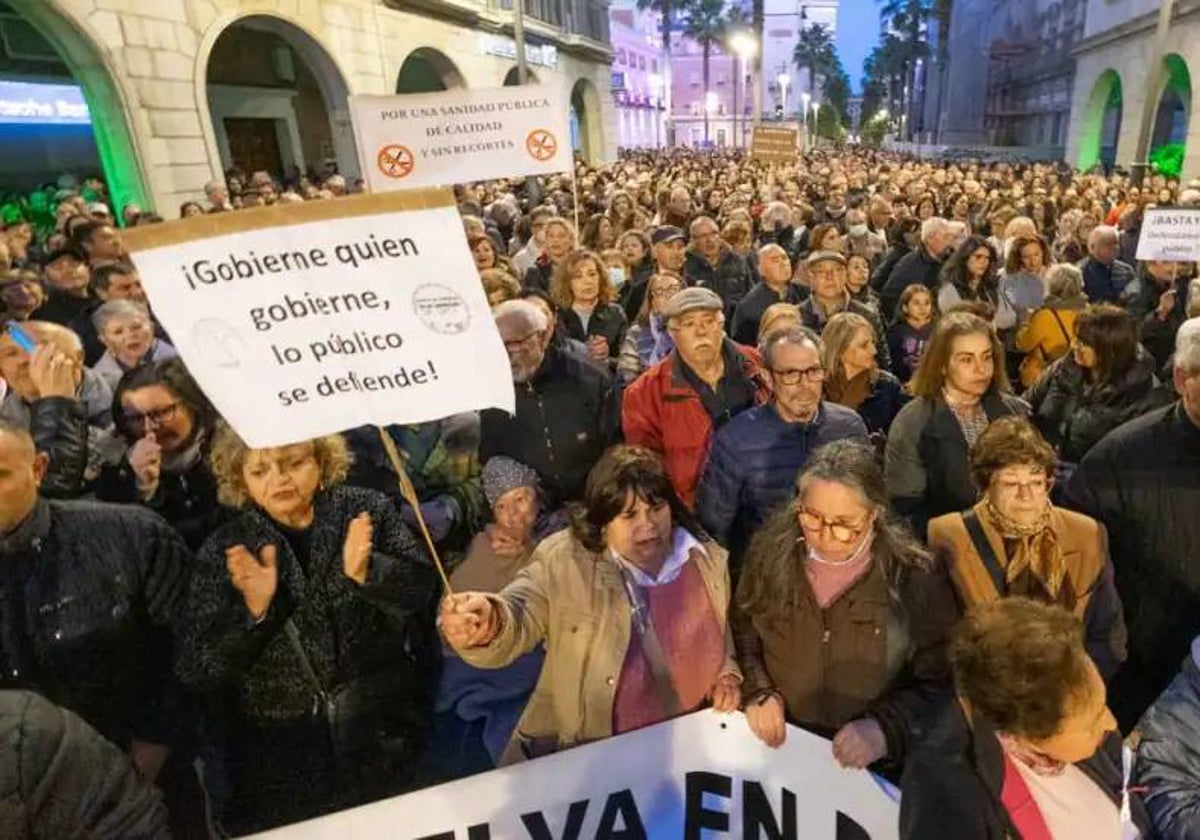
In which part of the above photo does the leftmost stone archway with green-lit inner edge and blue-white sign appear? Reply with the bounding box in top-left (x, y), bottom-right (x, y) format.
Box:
top-left (0, 0), bottom-right (151, 218)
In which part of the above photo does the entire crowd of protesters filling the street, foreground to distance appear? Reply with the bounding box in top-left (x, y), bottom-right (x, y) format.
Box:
top-left (0, 150), bottom-right (1200, 840)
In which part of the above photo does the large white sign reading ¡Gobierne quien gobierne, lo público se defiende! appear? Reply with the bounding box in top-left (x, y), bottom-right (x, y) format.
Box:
top-left (126, 191), bottom-right (514, 448)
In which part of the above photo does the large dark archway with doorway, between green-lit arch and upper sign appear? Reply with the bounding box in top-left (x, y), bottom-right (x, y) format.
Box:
top-left (205, 14), bottom-right (359, 179)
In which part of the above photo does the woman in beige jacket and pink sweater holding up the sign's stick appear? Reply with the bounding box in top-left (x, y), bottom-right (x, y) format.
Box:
top-left (439, 446), bottom-right (740, 755)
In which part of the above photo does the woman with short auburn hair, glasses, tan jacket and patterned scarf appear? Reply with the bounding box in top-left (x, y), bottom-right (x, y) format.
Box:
top-left (929, 416), bottom-right (1126, 679)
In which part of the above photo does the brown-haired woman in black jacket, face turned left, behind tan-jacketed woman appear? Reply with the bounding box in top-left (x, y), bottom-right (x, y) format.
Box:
top-left (1025, 304), bottom-right (1171, 463)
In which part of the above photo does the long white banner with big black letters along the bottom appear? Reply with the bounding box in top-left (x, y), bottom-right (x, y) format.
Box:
top-left (248, 710), bottom-right (900, 840)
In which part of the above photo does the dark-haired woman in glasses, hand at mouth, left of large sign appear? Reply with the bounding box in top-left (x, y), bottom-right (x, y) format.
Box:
top-left (96, 359), bottom-right (224, 550)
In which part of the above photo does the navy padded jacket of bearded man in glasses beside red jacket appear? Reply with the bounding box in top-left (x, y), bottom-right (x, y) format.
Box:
top-left (696, 402), bottom-right (866, 554)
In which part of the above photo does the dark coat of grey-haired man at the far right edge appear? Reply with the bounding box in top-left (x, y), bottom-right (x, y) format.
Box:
top-left (1066, 403), bottom-right (1200, 714)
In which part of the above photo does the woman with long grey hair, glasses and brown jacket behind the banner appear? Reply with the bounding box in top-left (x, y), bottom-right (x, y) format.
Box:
top-left (732, 440), bottom-right (958, 772)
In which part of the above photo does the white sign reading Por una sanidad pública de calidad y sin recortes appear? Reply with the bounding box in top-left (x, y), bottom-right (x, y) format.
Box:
top-left (350, 85), bottom-right (574, 192)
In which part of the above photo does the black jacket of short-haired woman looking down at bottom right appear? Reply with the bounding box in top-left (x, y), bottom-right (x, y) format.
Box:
top-left (900, 697), bottom-right (1153, 840)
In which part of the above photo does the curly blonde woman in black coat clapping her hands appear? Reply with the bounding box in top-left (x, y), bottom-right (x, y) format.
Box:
top-left (176, 427), bottom-right (437, 835)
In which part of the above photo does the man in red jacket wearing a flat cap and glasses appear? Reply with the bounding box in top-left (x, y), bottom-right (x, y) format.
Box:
top-left (620, 288), bottom-right (768, 508)
